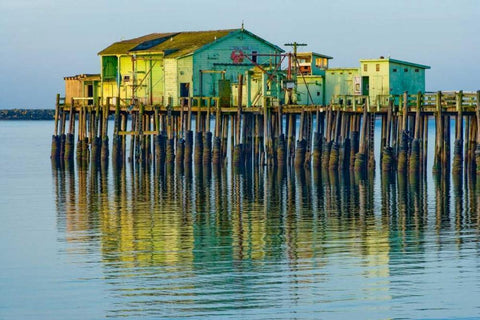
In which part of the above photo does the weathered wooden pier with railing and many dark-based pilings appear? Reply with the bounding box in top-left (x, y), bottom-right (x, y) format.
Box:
top-left (51, 90), bottom-right (480, 175)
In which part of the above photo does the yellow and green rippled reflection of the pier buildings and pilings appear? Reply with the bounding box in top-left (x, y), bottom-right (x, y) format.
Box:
top-left (53, 165), bottom-right (480, 318)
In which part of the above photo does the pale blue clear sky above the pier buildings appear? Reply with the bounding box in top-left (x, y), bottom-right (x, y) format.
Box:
top-left (0, 0), bottom-right (480, 109)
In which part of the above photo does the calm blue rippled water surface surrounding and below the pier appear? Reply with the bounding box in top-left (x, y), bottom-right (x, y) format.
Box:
top-left (0, 122), bottom-right (480, 319)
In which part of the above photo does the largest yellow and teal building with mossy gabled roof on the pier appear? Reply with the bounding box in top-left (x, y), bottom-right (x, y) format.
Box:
top-left (99, 28), bottom-right (283, 105)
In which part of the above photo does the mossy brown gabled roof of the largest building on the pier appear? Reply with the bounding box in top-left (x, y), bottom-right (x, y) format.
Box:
top-left (98, 29), bottom-right (283, 58)
